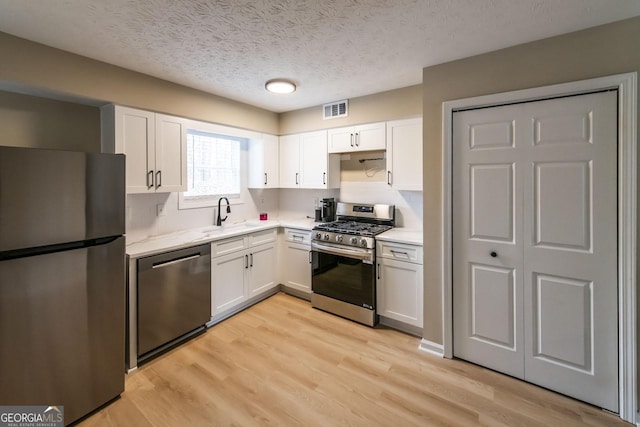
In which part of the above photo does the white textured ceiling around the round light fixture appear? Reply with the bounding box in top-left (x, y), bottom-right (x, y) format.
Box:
top-left (0, 0), bottom-right (640, 112)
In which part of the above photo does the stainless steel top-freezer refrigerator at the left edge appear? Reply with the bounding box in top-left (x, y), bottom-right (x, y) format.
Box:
top-left (0, 147), bottom-right (126, 424)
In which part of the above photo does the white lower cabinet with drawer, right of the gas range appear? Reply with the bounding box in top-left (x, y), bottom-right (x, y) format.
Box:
top-left (376, 241), bottom-right (423, 328)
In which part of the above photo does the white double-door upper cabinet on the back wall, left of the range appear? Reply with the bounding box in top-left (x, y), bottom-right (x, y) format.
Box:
top-left (280, 130), bottom-right (340, 188)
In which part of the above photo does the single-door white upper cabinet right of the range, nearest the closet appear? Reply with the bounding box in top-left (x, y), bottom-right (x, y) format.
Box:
top-left (387, 118), bottom-right (422, 191)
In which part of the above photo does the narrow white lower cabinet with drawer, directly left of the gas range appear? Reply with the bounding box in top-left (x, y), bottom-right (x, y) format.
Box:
top-left (281, 228), bottom-right (311, 298)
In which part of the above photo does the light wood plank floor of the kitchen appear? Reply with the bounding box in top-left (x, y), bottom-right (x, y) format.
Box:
top-left (81, 293), bottom-right (631, 427)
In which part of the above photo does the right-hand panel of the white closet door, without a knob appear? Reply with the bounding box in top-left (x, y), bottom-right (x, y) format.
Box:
top-left (523, 92), bottom-right (618, 412)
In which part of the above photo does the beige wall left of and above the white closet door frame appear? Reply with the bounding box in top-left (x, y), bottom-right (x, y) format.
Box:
top-left (423, 18), bottom-right (640, 343)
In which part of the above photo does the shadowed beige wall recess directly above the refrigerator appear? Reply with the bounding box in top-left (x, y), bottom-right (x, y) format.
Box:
top-left (0, 91), bottom-right (100, 151)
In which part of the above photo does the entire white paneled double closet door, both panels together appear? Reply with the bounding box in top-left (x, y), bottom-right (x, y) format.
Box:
top-left (453, 92), bottom-right (618, 411)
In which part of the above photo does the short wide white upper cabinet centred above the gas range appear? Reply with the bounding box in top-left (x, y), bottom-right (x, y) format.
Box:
top-left (328, 122), bottom-right (386, 153)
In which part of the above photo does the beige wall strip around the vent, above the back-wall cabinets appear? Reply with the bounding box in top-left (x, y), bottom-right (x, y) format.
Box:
top-left (280, 85), bottom-right (423, 135)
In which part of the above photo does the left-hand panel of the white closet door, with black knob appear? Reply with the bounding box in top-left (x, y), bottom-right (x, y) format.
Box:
top-left (453, 102), bottom-right (524, 377)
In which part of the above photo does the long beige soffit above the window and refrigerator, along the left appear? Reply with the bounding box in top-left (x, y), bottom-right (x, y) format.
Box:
top-left (0, 33), bottom-right (279, 145)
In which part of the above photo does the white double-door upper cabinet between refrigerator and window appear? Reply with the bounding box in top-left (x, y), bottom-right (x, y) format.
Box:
top-left (101, 105), bottom-right (187, 193)
